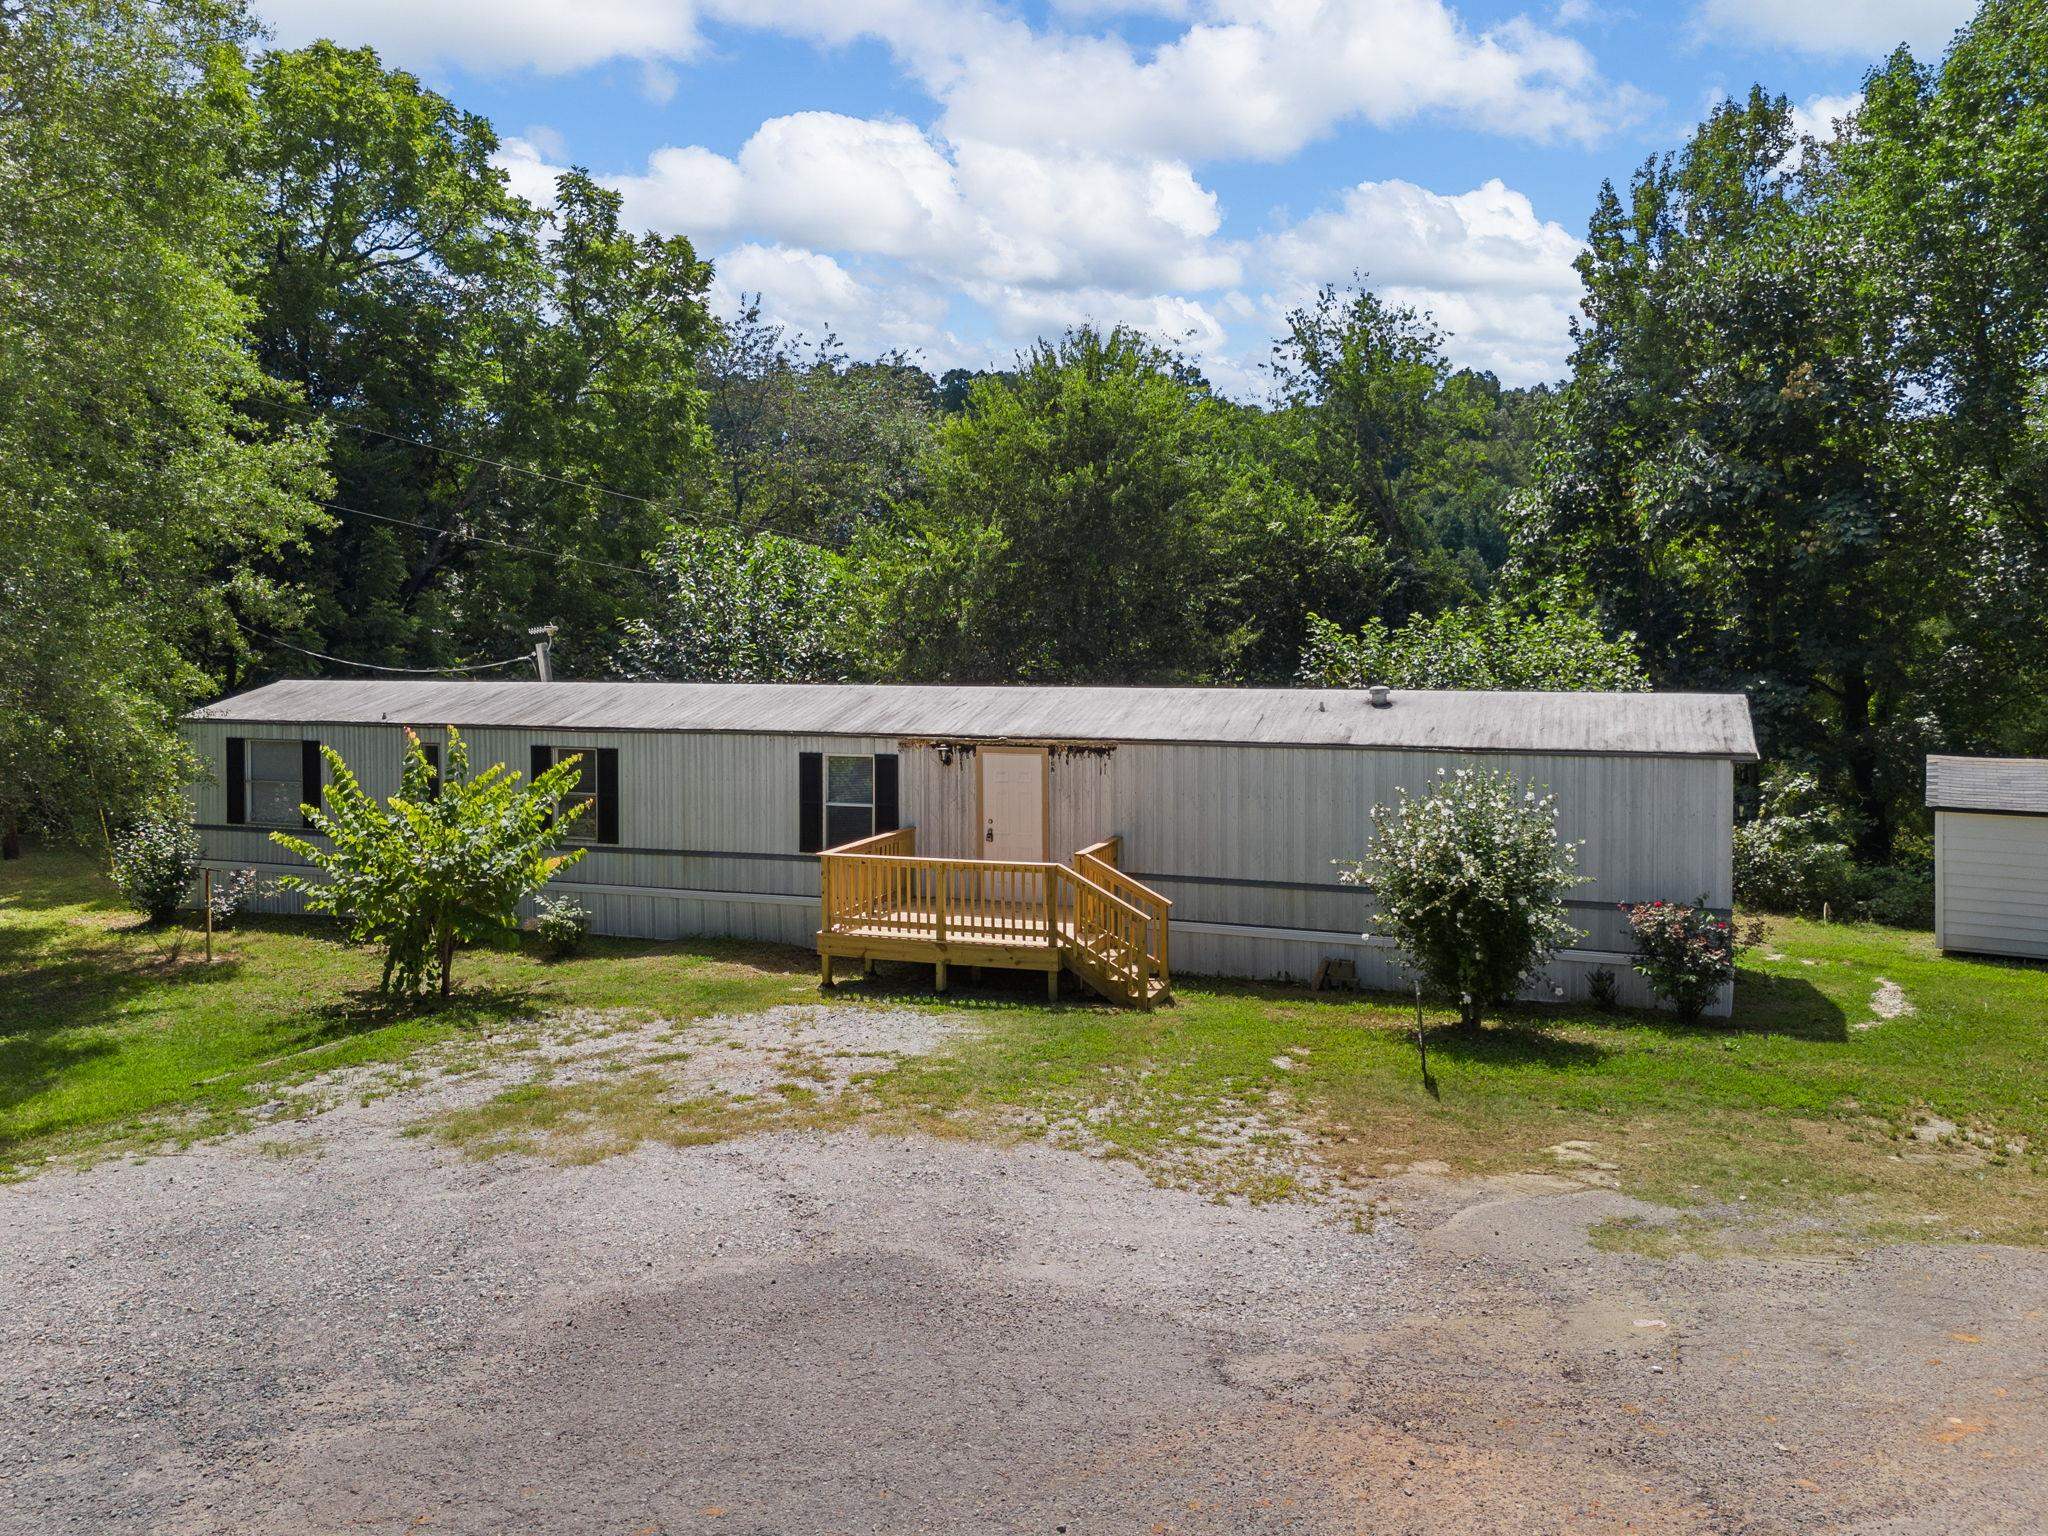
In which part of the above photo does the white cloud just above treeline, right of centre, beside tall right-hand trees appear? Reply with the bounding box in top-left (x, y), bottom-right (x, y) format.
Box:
top-left (1257, 180), bottom-right (1579, 385)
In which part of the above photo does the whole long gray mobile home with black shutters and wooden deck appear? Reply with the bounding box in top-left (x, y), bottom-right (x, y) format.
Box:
top-left (184, 680), bottom-right (1755, 1012)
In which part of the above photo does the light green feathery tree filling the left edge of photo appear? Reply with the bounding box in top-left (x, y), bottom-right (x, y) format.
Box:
top-left (0, 0), bottom-right (324, 854)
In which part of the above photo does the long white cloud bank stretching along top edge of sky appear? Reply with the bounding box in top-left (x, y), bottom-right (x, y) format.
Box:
top-left (262, 0), bottom-right (1630, 160)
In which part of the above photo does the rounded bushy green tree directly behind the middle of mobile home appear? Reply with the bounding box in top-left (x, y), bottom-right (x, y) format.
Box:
top-left (850, 328), bottom-right (1382, 682)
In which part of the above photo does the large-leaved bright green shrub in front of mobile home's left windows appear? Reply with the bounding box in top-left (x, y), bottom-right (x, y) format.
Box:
top-left (270, 727), bottom-right (586, 997)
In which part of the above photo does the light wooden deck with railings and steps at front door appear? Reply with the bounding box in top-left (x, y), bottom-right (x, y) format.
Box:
top-left (817, 827), bottom-right (1174, 1008)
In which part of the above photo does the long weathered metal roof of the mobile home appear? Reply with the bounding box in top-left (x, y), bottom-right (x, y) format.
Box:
top-left (188, 680), bottom-right (1757, 762)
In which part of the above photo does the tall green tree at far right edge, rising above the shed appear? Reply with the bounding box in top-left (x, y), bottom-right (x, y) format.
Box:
top-left (1821, 0), bottom-right (2048, 754)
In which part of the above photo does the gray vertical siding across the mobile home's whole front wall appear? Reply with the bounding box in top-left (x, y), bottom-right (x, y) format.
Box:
top-left (184, 721), bottom-right (1733, 1011)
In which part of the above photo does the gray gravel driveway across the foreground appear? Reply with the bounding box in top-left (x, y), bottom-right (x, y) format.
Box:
top-left (0, 1016), bottom-right (2048, 1536)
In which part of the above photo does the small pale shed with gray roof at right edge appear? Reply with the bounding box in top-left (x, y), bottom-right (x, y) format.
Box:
top-left (1927, 758), bottom-right (2048, 961)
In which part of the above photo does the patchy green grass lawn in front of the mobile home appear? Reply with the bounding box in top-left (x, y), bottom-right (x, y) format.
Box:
top-left (0, 850), bottom-right (2048, 1247)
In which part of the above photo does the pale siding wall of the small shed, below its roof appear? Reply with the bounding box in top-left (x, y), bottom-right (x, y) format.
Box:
top-left (1933, 811), bottom-right (2048, 961)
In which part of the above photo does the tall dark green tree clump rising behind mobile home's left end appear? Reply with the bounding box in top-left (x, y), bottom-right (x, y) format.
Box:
top-left (248, 43), bottom-right (715, 668)
